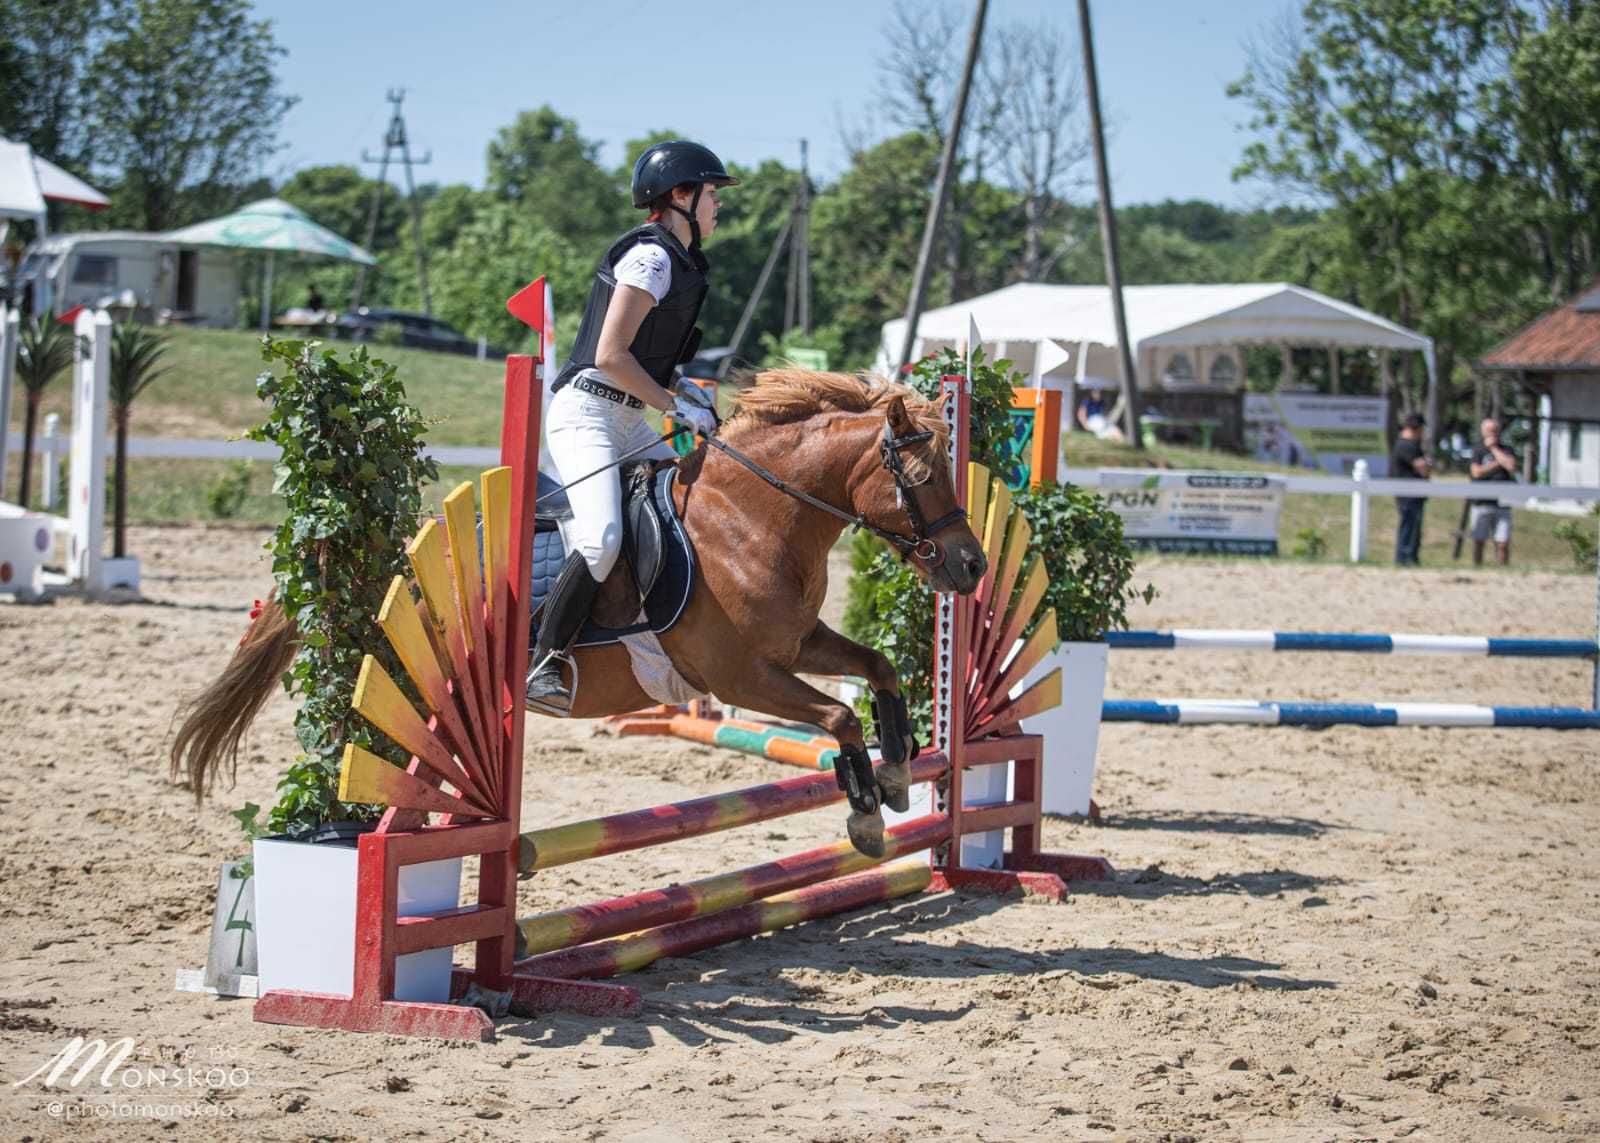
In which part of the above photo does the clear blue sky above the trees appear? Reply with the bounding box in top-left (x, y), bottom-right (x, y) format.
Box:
top-left (256, 0), bottom-right (1290, 207)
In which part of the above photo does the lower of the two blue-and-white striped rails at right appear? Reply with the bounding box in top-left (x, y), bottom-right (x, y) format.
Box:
top-left (1101, 698), bottom-right (1600, 730)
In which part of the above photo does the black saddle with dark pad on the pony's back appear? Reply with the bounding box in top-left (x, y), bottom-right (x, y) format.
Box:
top-left (528, 461), bottom-right (696, 648)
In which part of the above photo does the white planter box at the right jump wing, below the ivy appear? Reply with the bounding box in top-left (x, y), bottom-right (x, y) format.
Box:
top-left (1013, 644), bottom-right (1110, 815)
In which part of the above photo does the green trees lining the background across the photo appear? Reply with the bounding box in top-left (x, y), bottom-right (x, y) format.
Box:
top-left (0, 0), bottom-right (1600, 426)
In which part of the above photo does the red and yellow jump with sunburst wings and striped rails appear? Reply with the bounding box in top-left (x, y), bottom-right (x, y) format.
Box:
top-left (254, 315), bottom-right (1110, 1041)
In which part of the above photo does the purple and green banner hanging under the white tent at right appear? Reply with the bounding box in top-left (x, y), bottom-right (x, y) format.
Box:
top-left (1245, 392), bottom-right (1389, 479)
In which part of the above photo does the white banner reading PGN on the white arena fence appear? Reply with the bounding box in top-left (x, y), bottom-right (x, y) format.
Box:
top-left (1099, 469), bottom-right (1285, 555)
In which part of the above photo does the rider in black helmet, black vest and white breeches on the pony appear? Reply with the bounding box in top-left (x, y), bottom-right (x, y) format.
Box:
top-left (528, 139), bottom-right (738, 712)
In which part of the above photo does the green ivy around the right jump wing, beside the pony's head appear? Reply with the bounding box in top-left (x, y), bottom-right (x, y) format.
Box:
top-left (843, 349), bottom-right (1155, 743)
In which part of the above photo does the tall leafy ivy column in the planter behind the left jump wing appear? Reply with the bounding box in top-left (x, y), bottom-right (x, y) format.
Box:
top-left (246, 338), bottom-right (438, 836)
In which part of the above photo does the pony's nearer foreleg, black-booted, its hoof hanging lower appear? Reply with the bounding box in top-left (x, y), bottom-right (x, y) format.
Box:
top-left (717, 661), bottom-right (886, 856)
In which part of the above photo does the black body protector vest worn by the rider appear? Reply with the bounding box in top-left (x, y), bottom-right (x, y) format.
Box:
top-left (550, 223), bottom-right (709, 392)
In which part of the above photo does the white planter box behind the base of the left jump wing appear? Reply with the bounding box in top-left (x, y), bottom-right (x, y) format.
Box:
top-left (254, 837), bottom-right (461, 1004)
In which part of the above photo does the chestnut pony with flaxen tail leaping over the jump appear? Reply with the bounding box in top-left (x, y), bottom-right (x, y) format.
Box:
top-left (171, 370), bottom-right (987, 855)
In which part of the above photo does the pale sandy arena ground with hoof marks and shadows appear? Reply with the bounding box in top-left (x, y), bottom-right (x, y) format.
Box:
top-left (0, 528), bottom-right (1600, 1140)
